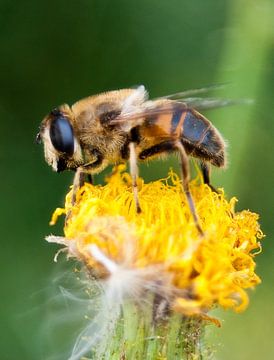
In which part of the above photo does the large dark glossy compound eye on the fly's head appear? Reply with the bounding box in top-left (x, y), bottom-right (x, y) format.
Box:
top-left (49, 115), bottom-right (74, 156)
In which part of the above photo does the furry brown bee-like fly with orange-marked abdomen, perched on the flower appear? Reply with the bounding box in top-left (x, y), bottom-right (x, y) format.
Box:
top-left (37, 86), bottom-right (229, 235)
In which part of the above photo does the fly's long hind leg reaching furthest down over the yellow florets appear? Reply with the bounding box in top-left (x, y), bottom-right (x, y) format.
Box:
top-left (175, 141), bottom-right (204, 236)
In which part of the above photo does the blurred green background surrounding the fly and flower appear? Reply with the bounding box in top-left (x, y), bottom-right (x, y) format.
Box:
top-left (0, 0), bottom-right (274, 360)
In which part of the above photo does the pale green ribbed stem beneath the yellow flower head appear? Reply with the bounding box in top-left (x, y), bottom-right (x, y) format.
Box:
top-left (92, 301), bottom-right (204, 360)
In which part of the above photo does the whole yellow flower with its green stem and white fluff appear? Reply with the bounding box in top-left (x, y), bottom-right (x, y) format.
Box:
top-left (47, 166), bottom-right (263, 359)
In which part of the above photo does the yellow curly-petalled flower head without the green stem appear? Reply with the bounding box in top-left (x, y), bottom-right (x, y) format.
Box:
top-left (50, 167), bottom-right (263, 315)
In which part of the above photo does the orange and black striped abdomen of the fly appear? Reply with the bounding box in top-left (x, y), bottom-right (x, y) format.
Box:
top-left (140, 103), bottom-right (225, 167)
